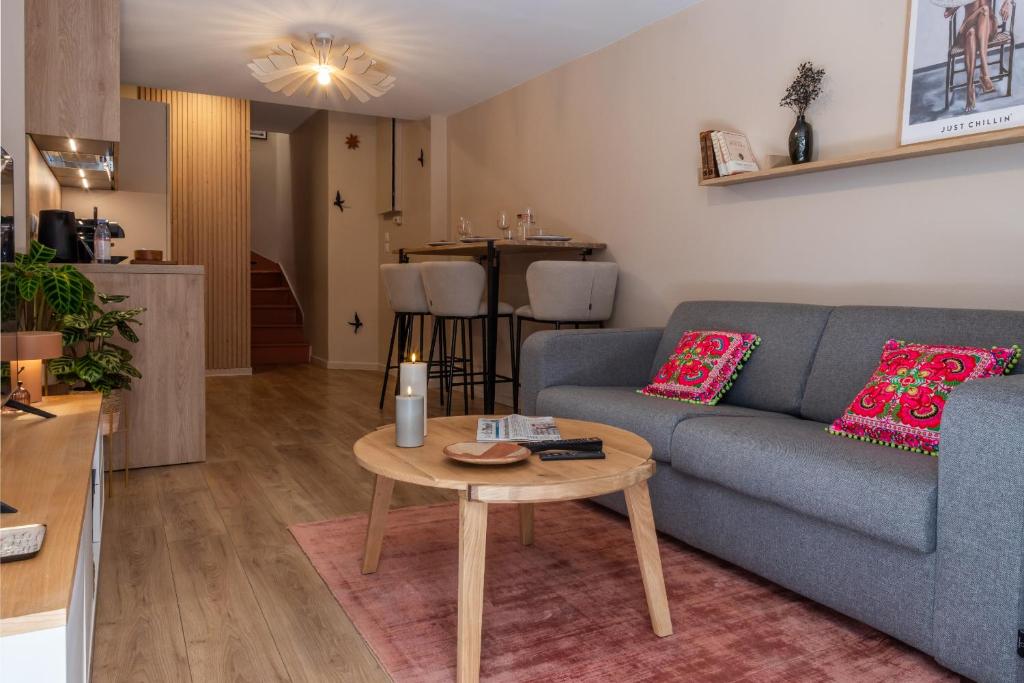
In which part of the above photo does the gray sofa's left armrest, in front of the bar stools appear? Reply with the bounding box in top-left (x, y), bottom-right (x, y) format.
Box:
top-left (520, 328), bottom-right (663, 415)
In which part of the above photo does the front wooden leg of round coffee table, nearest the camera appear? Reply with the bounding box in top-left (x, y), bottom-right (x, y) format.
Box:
top-left (457, 492), bottom-right (487, 683)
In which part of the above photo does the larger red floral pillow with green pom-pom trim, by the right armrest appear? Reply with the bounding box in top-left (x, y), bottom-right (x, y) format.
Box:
top-left (828, 339), bottom-right (1020, 455)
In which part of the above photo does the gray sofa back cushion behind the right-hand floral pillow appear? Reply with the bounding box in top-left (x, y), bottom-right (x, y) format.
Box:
top-left (798, 306), bottom-right (1024, 422)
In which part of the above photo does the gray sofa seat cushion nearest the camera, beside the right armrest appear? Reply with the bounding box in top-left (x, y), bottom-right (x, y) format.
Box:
top-left (672, 418), bottom-right (938, 553)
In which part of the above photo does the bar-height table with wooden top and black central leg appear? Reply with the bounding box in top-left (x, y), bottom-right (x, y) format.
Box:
top-left (397, 238), bottom-right (606, 415)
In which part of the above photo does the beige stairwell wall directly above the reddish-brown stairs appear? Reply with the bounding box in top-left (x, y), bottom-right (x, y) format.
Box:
top-left (251, 133), bottom-right (296, 283)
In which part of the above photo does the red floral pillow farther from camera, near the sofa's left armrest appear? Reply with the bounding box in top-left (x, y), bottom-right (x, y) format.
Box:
top-left (638, 330), bottom-right (761, 405)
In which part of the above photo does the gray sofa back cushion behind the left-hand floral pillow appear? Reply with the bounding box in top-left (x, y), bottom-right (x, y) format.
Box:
top-left (650, 301), bottom-right (831, 415)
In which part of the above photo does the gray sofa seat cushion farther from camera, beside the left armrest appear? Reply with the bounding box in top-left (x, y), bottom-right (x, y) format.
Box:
top-left (536, 386), bottom-right (796, 463)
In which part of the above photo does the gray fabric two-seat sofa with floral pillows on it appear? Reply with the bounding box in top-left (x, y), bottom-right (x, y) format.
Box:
top-left (521, 301), bottom-right (1024, 681)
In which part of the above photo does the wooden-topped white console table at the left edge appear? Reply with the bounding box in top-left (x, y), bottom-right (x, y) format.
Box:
top-left (0, 393), bottom-right (104, 683)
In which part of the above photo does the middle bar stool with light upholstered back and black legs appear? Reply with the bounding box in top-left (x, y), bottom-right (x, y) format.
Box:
top-left (420, 261), bottom-right (515, 415)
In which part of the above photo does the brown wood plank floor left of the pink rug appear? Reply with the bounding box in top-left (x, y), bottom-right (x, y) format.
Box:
top-left (92, 366), bottom-right (507, 683)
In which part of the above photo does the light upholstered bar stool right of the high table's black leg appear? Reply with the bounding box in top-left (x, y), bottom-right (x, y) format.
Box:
top-left (512, 261), bottom-right (618, 413)
